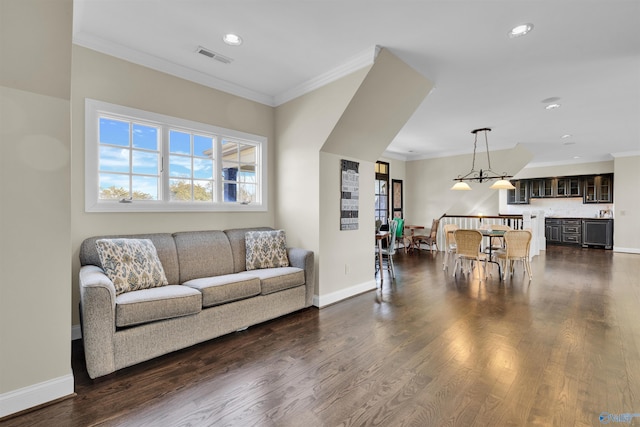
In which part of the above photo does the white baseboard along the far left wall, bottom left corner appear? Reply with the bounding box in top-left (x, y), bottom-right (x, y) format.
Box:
top-left (0, 374), bottom-right (74, 418)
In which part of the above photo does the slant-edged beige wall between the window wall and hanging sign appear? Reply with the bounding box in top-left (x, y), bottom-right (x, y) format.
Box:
top-left (276, 67), bottom-right (369, 295)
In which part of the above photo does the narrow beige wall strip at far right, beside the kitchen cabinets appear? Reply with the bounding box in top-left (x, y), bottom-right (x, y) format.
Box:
top-left (613, 155), bottom-right (640, 253)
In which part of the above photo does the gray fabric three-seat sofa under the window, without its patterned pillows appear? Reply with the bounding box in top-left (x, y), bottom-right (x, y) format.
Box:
top-left (79, 228), bottom-right (314, 378)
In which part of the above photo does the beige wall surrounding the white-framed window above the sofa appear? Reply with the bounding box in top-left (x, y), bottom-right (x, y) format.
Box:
top-left (71, 46), bottom-right (276, 324)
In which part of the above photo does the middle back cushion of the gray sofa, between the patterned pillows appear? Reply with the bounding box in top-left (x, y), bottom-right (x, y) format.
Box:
top-left (173, 230), bottom-right (233, 283)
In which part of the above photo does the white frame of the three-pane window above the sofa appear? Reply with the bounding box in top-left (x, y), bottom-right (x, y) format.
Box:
top-left (85, 98), bottom-right (268, 212)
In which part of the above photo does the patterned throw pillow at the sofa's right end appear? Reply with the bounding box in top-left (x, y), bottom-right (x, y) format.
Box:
top-left (244, 230), bottom-right (289, 270)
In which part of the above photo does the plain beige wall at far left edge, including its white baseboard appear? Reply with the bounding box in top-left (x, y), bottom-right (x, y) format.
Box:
top-left (0, 0), bottom-right (73, 417)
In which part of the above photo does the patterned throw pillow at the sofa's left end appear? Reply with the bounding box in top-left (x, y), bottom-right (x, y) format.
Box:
top-left (96, 239), bottom-right (169, 295)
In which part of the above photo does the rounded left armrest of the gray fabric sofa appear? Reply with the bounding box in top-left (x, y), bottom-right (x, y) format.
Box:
top-left (80, 265), bottom-right (116, 378)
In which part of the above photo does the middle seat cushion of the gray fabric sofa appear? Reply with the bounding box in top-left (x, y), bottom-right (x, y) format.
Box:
top-left (183, 274), bottom-right (260, 307)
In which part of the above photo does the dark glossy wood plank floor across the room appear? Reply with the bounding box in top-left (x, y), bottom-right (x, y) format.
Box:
top-left (0, 246), bottom-right (640, 427)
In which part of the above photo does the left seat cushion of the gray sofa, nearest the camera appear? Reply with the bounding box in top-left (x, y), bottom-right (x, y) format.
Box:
top-left (116, 285), bottom-right (202, 327)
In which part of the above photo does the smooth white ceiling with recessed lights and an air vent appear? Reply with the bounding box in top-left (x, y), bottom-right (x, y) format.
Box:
top-left (73, 0), bottom-right (640, 166)
